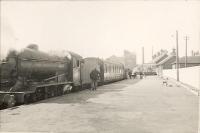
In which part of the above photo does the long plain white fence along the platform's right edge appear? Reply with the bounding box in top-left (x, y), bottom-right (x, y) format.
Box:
top-left (163, 66), bottom-right (200, 90)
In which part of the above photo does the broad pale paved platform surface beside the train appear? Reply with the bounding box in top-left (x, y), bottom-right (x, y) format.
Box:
top-left (0, 76), bottom-right (198, 133)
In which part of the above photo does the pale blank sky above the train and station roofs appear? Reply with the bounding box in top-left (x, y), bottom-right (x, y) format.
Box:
top-left (0, 0), bottom-right (200, 64)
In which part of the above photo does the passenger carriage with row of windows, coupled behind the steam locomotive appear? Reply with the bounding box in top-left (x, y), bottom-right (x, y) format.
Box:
top-left (81, 57), bottom-right (124, 88)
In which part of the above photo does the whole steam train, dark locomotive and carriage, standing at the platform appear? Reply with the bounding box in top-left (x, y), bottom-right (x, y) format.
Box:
top-left (0, 45), bottom-right (126, 109)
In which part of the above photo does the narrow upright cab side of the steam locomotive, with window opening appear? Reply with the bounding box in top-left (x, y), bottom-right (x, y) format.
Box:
top-left (73, 58), bottom-right (80, 86)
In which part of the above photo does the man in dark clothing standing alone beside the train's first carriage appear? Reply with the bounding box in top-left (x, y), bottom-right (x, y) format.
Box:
top-left (90, 68), bottom-right (100, 90)
